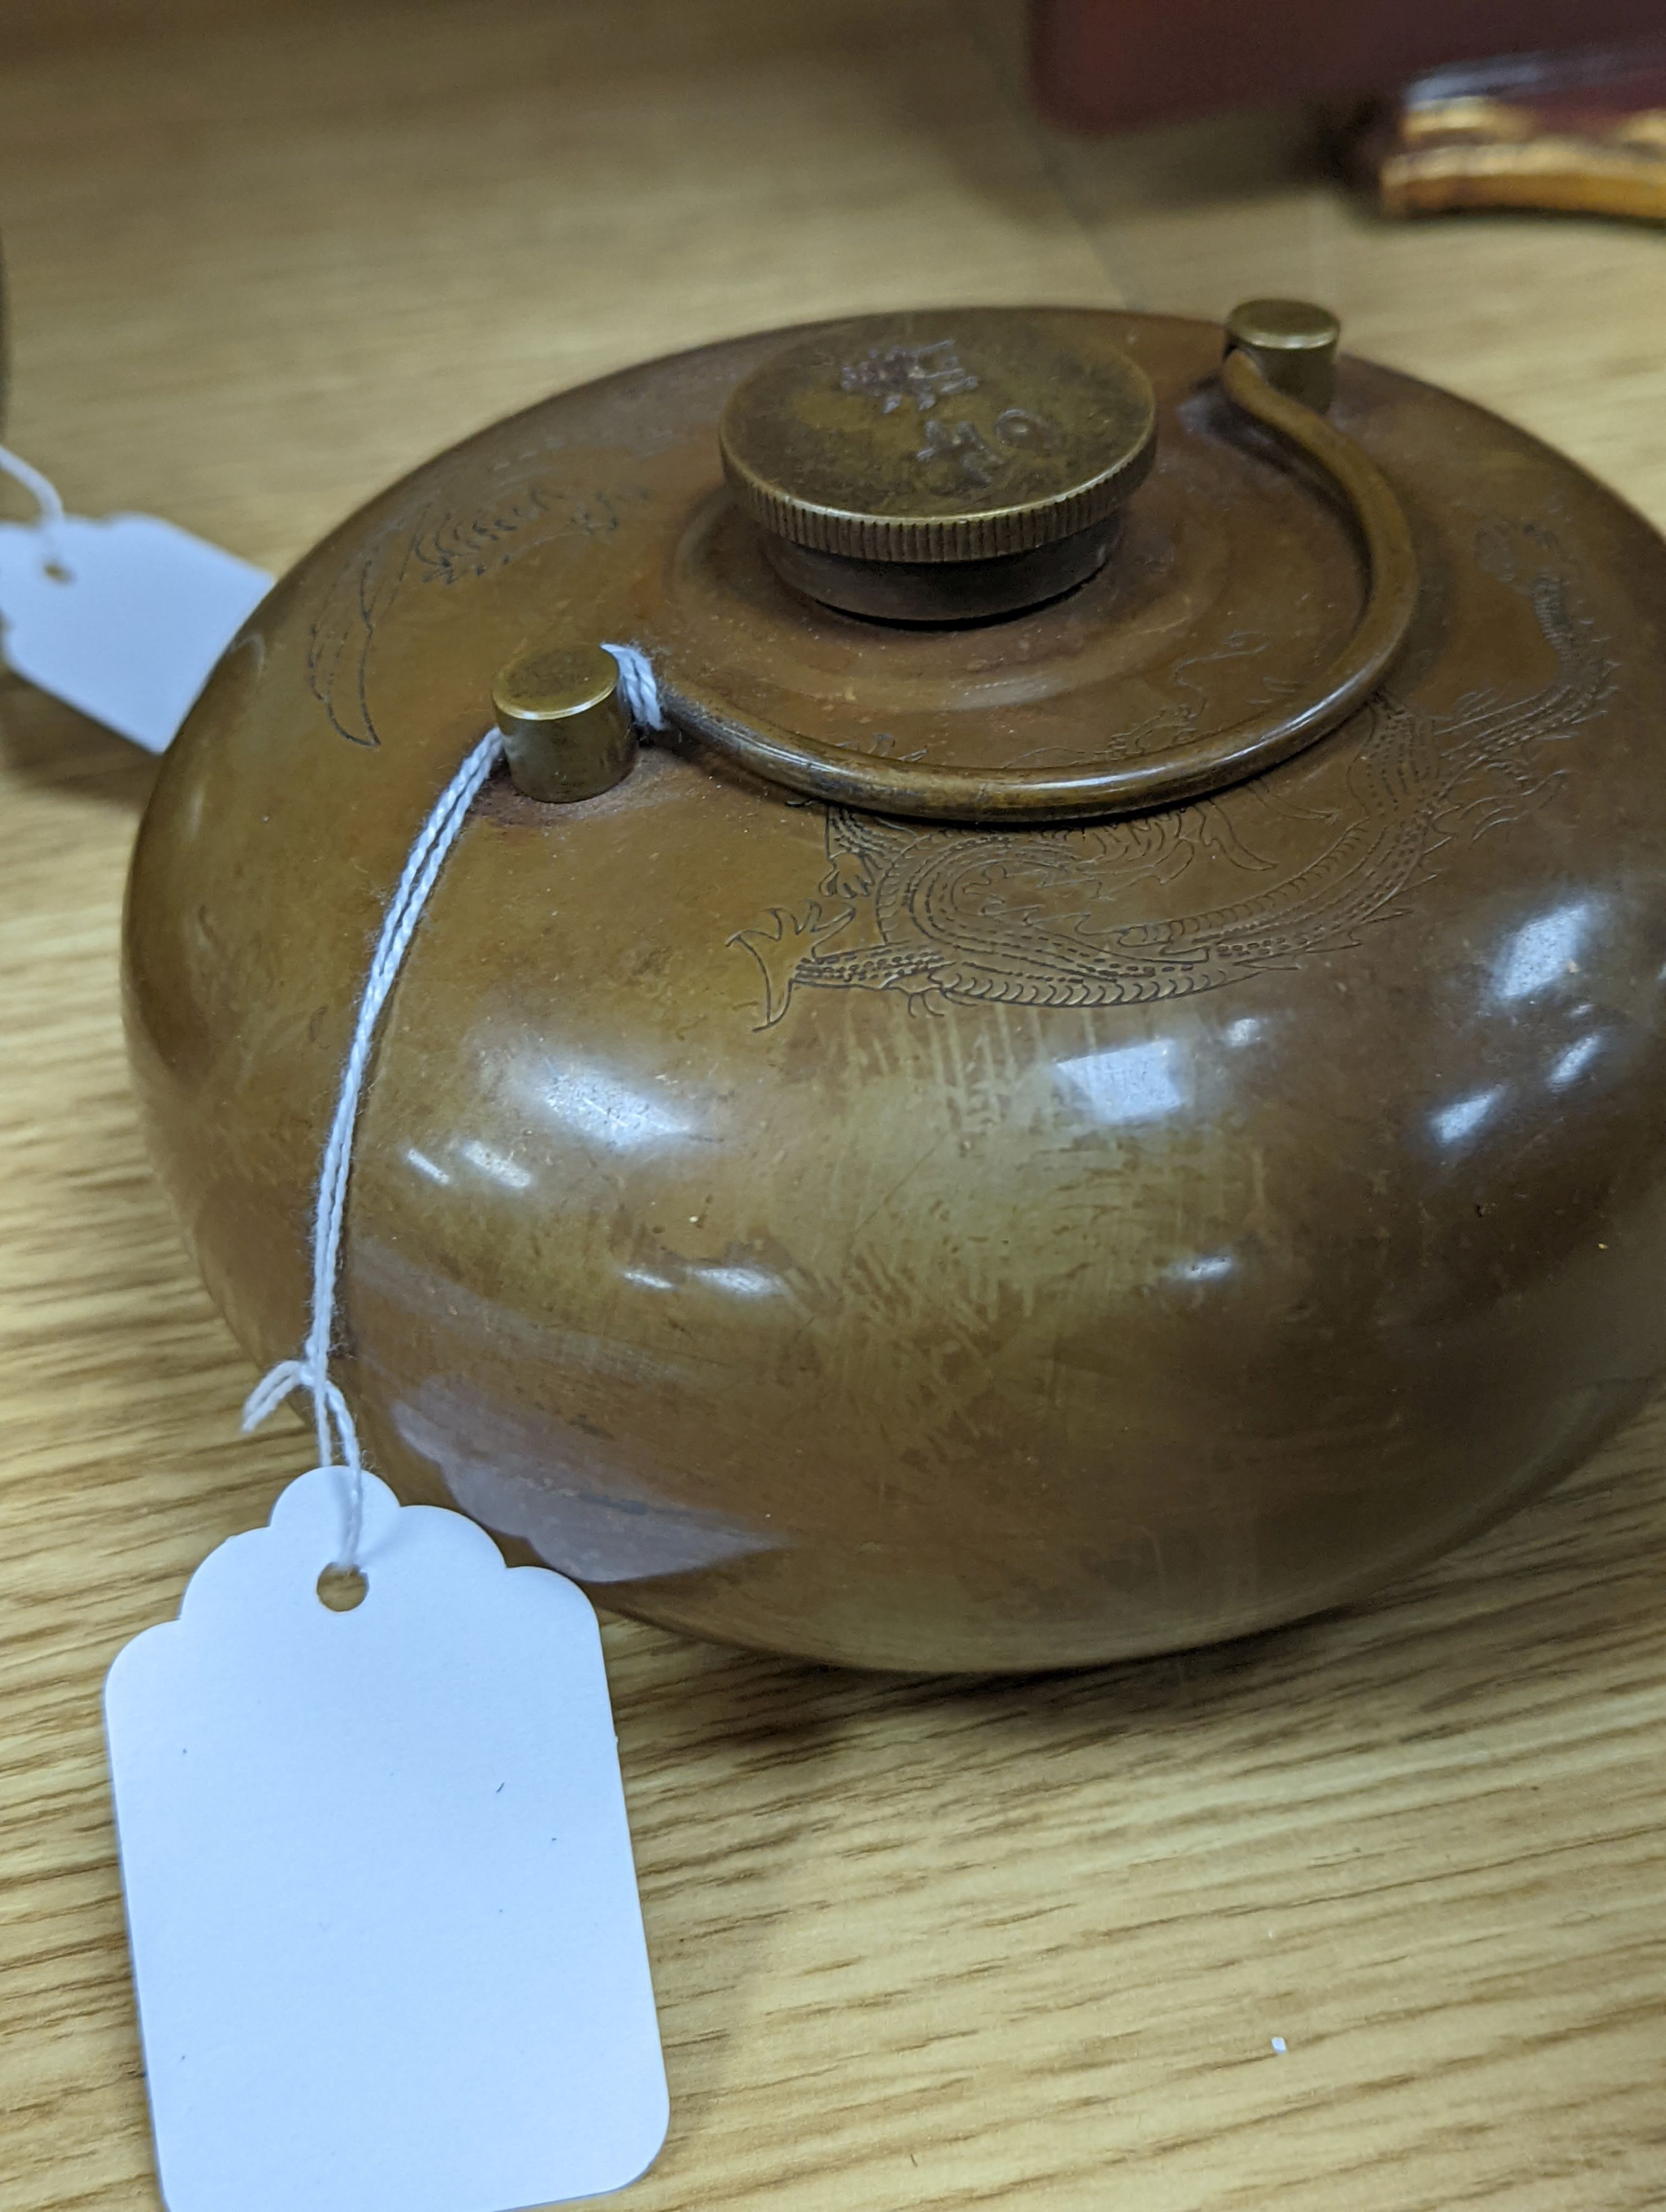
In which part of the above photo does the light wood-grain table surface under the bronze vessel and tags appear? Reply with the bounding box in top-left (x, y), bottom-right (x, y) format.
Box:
top-left (0, 0), bottom-right (1666, 2212)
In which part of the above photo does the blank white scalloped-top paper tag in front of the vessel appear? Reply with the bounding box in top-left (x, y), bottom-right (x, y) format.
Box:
top-left (104, 1471), bottom-right (668, 2212)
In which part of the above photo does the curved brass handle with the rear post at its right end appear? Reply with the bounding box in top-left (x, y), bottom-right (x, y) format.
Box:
top-left (659, 301), bottom-right (1418, 823)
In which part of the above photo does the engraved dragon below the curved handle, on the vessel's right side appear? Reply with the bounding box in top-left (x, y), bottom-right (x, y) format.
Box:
top-left (730, 557), bottom-right (1613, 1027)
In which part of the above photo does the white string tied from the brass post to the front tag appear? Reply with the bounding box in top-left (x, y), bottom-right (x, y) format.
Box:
top-left (242, 641), bottom-right (666, 1573)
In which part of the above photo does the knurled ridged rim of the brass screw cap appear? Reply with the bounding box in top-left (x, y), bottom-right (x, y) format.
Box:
top-left (719, 416), bottom-right (1157, 562)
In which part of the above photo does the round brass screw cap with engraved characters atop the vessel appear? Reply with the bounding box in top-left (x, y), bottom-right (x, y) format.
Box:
top-left (717, 308), bottom-right (1157, 622)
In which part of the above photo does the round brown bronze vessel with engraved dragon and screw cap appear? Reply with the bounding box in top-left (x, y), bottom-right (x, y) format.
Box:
top-left (126, 301), bottom-right (1666, 1670)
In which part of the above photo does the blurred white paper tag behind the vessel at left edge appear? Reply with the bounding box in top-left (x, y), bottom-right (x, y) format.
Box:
top-left (0, 515), bottom-right (272, 752)
